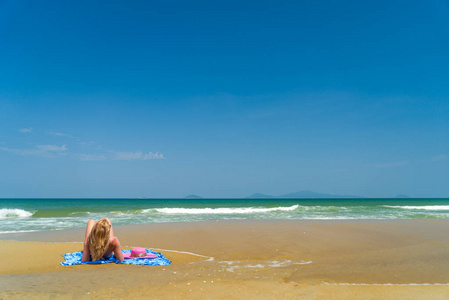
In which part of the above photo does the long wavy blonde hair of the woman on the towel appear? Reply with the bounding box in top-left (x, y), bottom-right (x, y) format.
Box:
top-left (89, 218), bottom-right (111, 261)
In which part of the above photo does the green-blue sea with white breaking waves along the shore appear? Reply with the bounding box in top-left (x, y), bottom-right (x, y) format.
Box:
top-left (0, 198), bottom-right (449, 234)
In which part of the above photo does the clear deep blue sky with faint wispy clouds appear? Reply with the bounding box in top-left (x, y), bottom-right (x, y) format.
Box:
top-left (0, 0), bottom-right (449, 197)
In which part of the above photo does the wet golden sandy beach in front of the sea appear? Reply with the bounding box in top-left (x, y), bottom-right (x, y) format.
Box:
top-left (0, 219), bottom-right (449, 299)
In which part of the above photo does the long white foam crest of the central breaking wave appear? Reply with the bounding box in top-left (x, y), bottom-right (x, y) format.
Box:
top-left (147, 204), bottom-right (299, 215)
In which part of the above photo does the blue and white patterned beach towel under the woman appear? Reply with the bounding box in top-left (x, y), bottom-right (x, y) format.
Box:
top-left (61, 249), bottom-right (171, 266)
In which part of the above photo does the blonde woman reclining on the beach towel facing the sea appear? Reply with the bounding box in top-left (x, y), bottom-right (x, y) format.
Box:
top-left (81, 218), bottom-right (125, 261)
